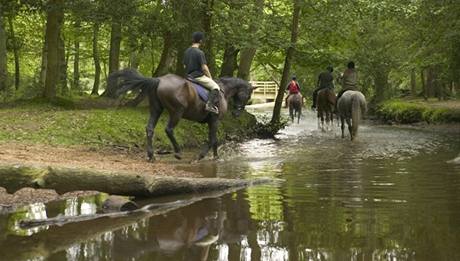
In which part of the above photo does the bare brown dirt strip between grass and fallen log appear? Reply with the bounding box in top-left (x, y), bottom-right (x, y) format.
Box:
top-left (0, 143), bottom-right (196, 177)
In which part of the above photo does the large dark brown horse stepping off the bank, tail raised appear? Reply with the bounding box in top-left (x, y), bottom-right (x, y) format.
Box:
top-left (109, 69), bottom-right (253, 161)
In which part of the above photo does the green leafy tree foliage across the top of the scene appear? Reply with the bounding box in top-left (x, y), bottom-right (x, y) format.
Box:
top-left (1, 0), bottom-right (460, 107)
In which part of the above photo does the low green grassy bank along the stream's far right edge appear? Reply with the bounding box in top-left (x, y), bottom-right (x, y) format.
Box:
top-left (376, 99), bottom-right (460, 123)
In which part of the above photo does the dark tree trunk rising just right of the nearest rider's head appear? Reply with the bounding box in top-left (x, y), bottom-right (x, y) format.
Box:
top-left (202, 0), bottom-right (216, 77)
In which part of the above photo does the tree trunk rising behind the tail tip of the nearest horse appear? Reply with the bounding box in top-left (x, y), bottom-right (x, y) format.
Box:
top-left (102, 18), bottom-right (121, 98)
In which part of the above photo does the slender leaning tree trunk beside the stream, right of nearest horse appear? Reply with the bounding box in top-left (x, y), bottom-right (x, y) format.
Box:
top-left (271, 0), bottom-right (300, 124)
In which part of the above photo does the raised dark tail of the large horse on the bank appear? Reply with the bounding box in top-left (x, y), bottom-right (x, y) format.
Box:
top-left (107, 69), bottom-right (160, 97)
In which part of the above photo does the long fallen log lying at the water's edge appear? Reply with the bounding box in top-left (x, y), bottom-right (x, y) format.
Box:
top-left (0, 165), bottom-right (270, 197)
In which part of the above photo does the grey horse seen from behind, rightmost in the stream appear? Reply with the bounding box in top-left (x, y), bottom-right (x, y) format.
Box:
top-left (337, 91), bottom-right (367, 141)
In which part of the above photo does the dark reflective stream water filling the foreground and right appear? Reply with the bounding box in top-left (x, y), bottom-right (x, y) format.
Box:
top-left (0, 110), bottom-right (460, 261)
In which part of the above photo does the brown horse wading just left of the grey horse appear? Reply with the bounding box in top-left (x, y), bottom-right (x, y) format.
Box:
top-left (316, 88), bottom-right (336, 131)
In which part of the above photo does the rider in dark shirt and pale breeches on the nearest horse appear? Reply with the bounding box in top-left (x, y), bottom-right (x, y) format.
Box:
top-left (183, 32), bottom-right (220, 114)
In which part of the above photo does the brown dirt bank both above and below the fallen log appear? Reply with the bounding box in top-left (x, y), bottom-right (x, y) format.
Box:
top-left (0, 143), bottom-right (196, 208)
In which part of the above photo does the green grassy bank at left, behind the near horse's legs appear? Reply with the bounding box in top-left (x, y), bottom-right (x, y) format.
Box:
top-left (0, 100), bottom-right (257, 149)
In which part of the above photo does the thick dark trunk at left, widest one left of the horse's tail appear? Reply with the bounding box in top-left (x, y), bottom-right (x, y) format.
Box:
top-left (43, 0), bottom-right (64, 98)
